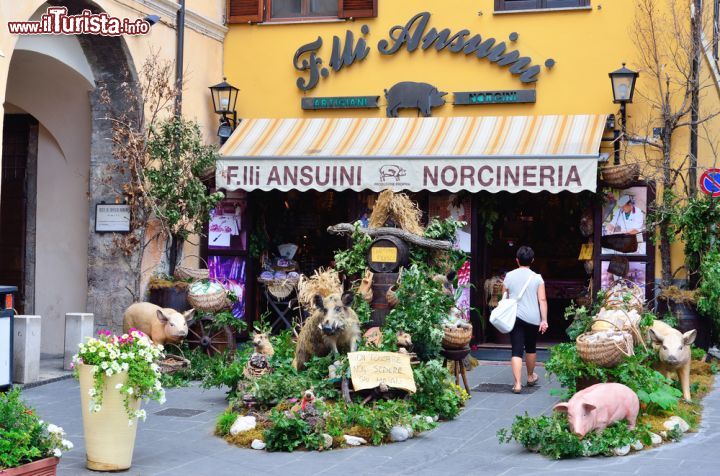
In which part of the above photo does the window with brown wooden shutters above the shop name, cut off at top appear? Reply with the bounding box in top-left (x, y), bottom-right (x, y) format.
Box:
top-left (227, 0), bottom-right (378, 23)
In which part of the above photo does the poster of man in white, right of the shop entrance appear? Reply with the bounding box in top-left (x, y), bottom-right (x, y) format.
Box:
top-left (602, 187), bottom-right (647, 255)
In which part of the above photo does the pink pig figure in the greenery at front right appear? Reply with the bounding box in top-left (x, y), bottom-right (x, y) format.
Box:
top-left (553, 383), bottom-right (640, 438)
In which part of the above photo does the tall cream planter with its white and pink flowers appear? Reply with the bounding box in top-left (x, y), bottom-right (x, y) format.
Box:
top-left (73, 329), bottom-right (165, 471)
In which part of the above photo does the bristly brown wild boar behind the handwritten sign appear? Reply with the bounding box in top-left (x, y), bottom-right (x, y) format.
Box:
top-left (293, 293), bottom-right (362, 370)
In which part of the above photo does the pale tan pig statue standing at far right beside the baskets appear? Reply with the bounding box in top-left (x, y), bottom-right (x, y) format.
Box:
top-left (648, 320), bottom-right (697, 402)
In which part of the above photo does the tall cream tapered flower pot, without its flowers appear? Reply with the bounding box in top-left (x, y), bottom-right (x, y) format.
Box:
top-left (79, 365), bottom-right (140, 471)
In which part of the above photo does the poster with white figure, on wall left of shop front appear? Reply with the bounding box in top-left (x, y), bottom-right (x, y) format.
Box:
top-left (208, 192), bottom-right (247, 251)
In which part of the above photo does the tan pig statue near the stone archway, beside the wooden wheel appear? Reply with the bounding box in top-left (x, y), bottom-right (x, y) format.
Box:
top-left (123, 302), bottom-right (195, 345)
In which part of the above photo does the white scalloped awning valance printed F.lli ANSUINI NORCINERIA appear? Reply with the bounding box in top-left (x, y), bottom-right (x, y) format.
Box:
top-left (216, 157), bottom-right (597, 193)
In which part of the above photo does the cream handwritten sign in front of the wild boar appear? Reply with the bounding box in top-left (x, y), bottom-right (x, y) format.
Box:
top-left (348, 352), bottom-right (417, 393)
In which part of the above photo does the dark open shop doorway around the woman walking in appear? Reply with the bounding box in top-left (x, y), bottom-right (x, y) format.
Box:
top-left (478, 192), bottom-right (593, 345)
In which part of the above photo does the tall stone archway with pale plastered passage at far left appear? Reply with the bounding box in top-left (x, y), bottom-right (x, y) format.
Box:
top-left (0, 0), bottom-right (136, 355)
